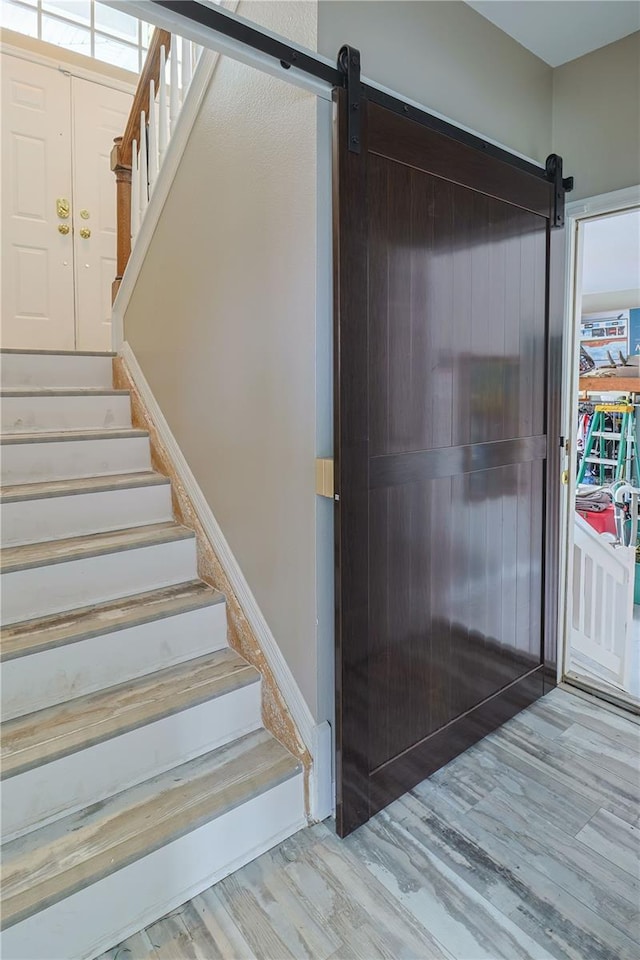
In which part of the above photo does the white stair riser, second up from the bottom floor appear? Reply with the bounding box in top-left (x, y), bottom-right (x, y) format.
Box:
top-left (2, 683), bottom-right (262, 841)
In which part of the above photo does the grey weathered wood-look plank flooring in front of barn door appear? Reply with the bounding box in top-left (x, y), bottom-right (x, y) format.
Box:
top-left (101, 690), bottom-right (640, 960)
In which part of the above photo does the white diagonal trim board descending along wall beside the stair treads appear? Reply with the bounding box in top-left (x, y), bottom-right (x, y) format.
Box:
top-left (120, 341), bottom-right (332, 820)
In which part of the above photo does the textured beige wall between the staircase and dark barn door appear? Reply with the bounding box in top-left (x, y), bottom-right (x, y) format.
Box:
top-left (124, 3), bottom-right (327, 719)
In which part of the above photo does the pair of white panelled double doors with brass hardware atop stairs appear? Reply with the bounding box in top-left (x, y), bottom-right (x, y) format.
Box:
top-left (0, 45), bottom-right (131, 350)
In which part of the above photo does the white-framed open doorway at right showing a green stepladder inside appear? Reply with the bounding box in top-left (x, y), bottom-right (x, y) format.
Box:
top-left (561, 189), bottom-right (640, 712)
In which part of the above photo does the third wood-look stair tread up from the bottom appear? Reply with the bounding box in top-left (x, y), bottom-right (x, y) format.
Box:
top-left (0, 580), bottom-right (225, 661)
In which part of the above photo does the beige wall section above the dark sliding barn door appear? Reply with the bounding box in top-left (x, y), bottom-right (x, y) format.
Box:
top-left (318, 0), bottom-right (552, 162)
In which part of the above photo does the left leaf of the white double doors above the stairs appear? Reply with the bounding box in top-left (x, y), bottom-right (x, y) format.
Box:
top-left (0, 53), bottom-right (75, 350)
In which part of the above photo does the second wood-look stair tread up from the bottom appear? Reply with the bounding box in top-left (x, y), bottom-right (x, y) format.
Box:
top-left (0, 647), bottom-right (260, 779)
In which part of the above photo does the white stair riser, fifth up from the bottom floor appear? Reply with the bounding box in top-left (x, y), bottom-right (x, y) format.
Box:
top-left (0, 483), bottom-right (173, 547)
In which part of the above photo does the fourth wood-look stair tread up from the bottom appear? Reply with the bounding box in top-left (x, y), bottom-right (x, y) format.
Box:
top-left (0, 520), bottom-right (195, 573)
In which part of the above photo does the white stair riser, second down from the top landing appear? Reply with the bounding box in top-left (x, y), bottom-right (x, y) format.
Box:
top-left (1, 394), bottom-right (131, 433)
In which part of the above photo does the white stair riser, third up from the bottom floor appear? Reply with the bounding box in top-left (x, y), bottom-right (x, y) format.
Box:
top-left (1, 603), bottom-right (227, 720)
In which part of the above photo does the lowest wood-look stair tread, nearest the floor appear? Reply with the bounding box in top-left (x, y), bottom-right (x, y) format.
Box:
top-left (2, 730), bottom-right (300, 927)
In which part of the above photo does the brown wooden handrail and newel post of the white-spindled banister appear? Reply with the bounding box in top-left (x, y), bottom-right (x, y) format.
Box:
top-left (111, 27), bottom-right (171, 300)
